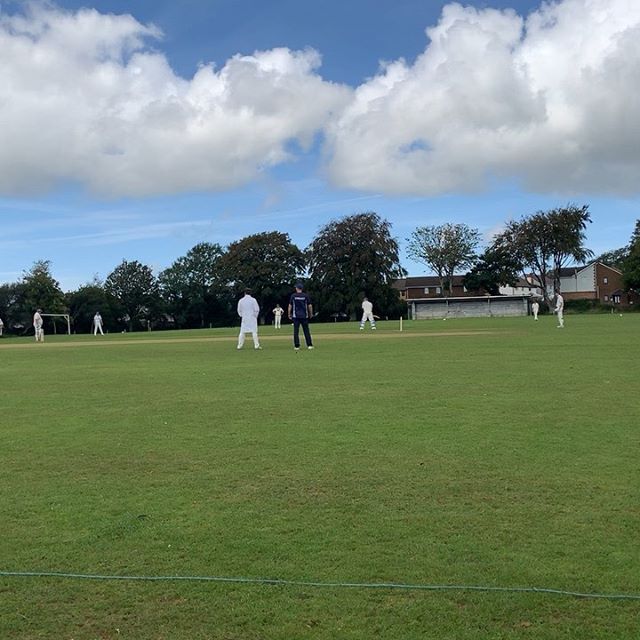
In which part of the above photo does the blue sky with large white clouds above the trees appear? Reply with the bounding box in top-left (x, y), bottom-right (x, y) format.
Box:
top-left (0, 0), bottom-right (640, 290)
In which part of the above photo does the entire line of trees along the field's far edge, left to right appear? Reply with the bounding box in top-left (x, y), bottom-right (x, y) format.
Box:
top-left (0, 204), bottom-right (640, 333)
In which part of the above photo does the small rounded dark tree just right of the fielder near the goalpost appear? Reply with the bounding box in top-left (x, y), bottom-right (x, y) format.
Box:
top-left (104, 260), bottom-right (159, 331)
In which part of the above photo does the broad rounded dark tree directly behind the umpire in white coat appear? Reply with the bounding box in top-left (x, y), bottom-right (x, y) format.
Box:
top-left (220, 231), bottom-right (305, 318)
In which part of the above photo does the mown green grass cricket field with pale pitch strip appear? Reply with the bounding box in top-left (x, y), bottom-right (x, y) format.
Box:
top-left (0, 314), bottom-right (640, 640)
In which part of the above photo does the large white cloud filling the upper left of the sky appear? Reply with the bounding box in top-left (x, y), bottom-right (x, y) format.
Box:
top-left (0, 3), bottom-right (349, 196)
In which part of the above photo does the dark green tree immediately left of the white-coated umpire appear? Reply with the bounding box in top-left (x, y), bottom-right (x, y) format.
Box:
top-left (158, 242), bottom-right (229, 327)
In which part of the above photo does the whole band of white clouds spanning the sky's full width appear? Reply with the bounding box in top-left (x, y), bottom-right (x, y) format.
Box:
top-left (0, 0), bottom-right (640, 196)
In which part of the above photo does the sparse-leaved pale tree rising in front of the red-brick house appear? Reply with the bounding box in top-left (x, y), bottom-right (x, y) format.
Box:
top-left (407, 223), bottom-right (480, 295)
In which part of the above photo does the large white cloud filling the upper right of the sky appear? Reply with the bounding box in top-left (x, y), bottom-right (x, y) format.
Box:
top-left (327, 0), bottom-right (640, 195)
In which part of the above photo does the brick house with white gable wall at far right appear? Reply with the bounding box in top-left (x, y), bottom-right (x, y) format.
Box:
top-left (547, 261), bottom-right (633, 304)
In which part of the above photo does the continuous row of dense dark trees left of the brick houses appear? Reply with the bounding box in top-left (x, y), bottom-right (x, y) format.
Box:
top-left (0, 212), bottom-right (406, 333)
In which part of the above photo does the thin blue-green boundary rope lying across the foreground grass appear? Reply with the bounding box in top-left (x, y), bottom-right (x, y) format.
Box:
top-left (0, 571), bottom-right (640, 600)
